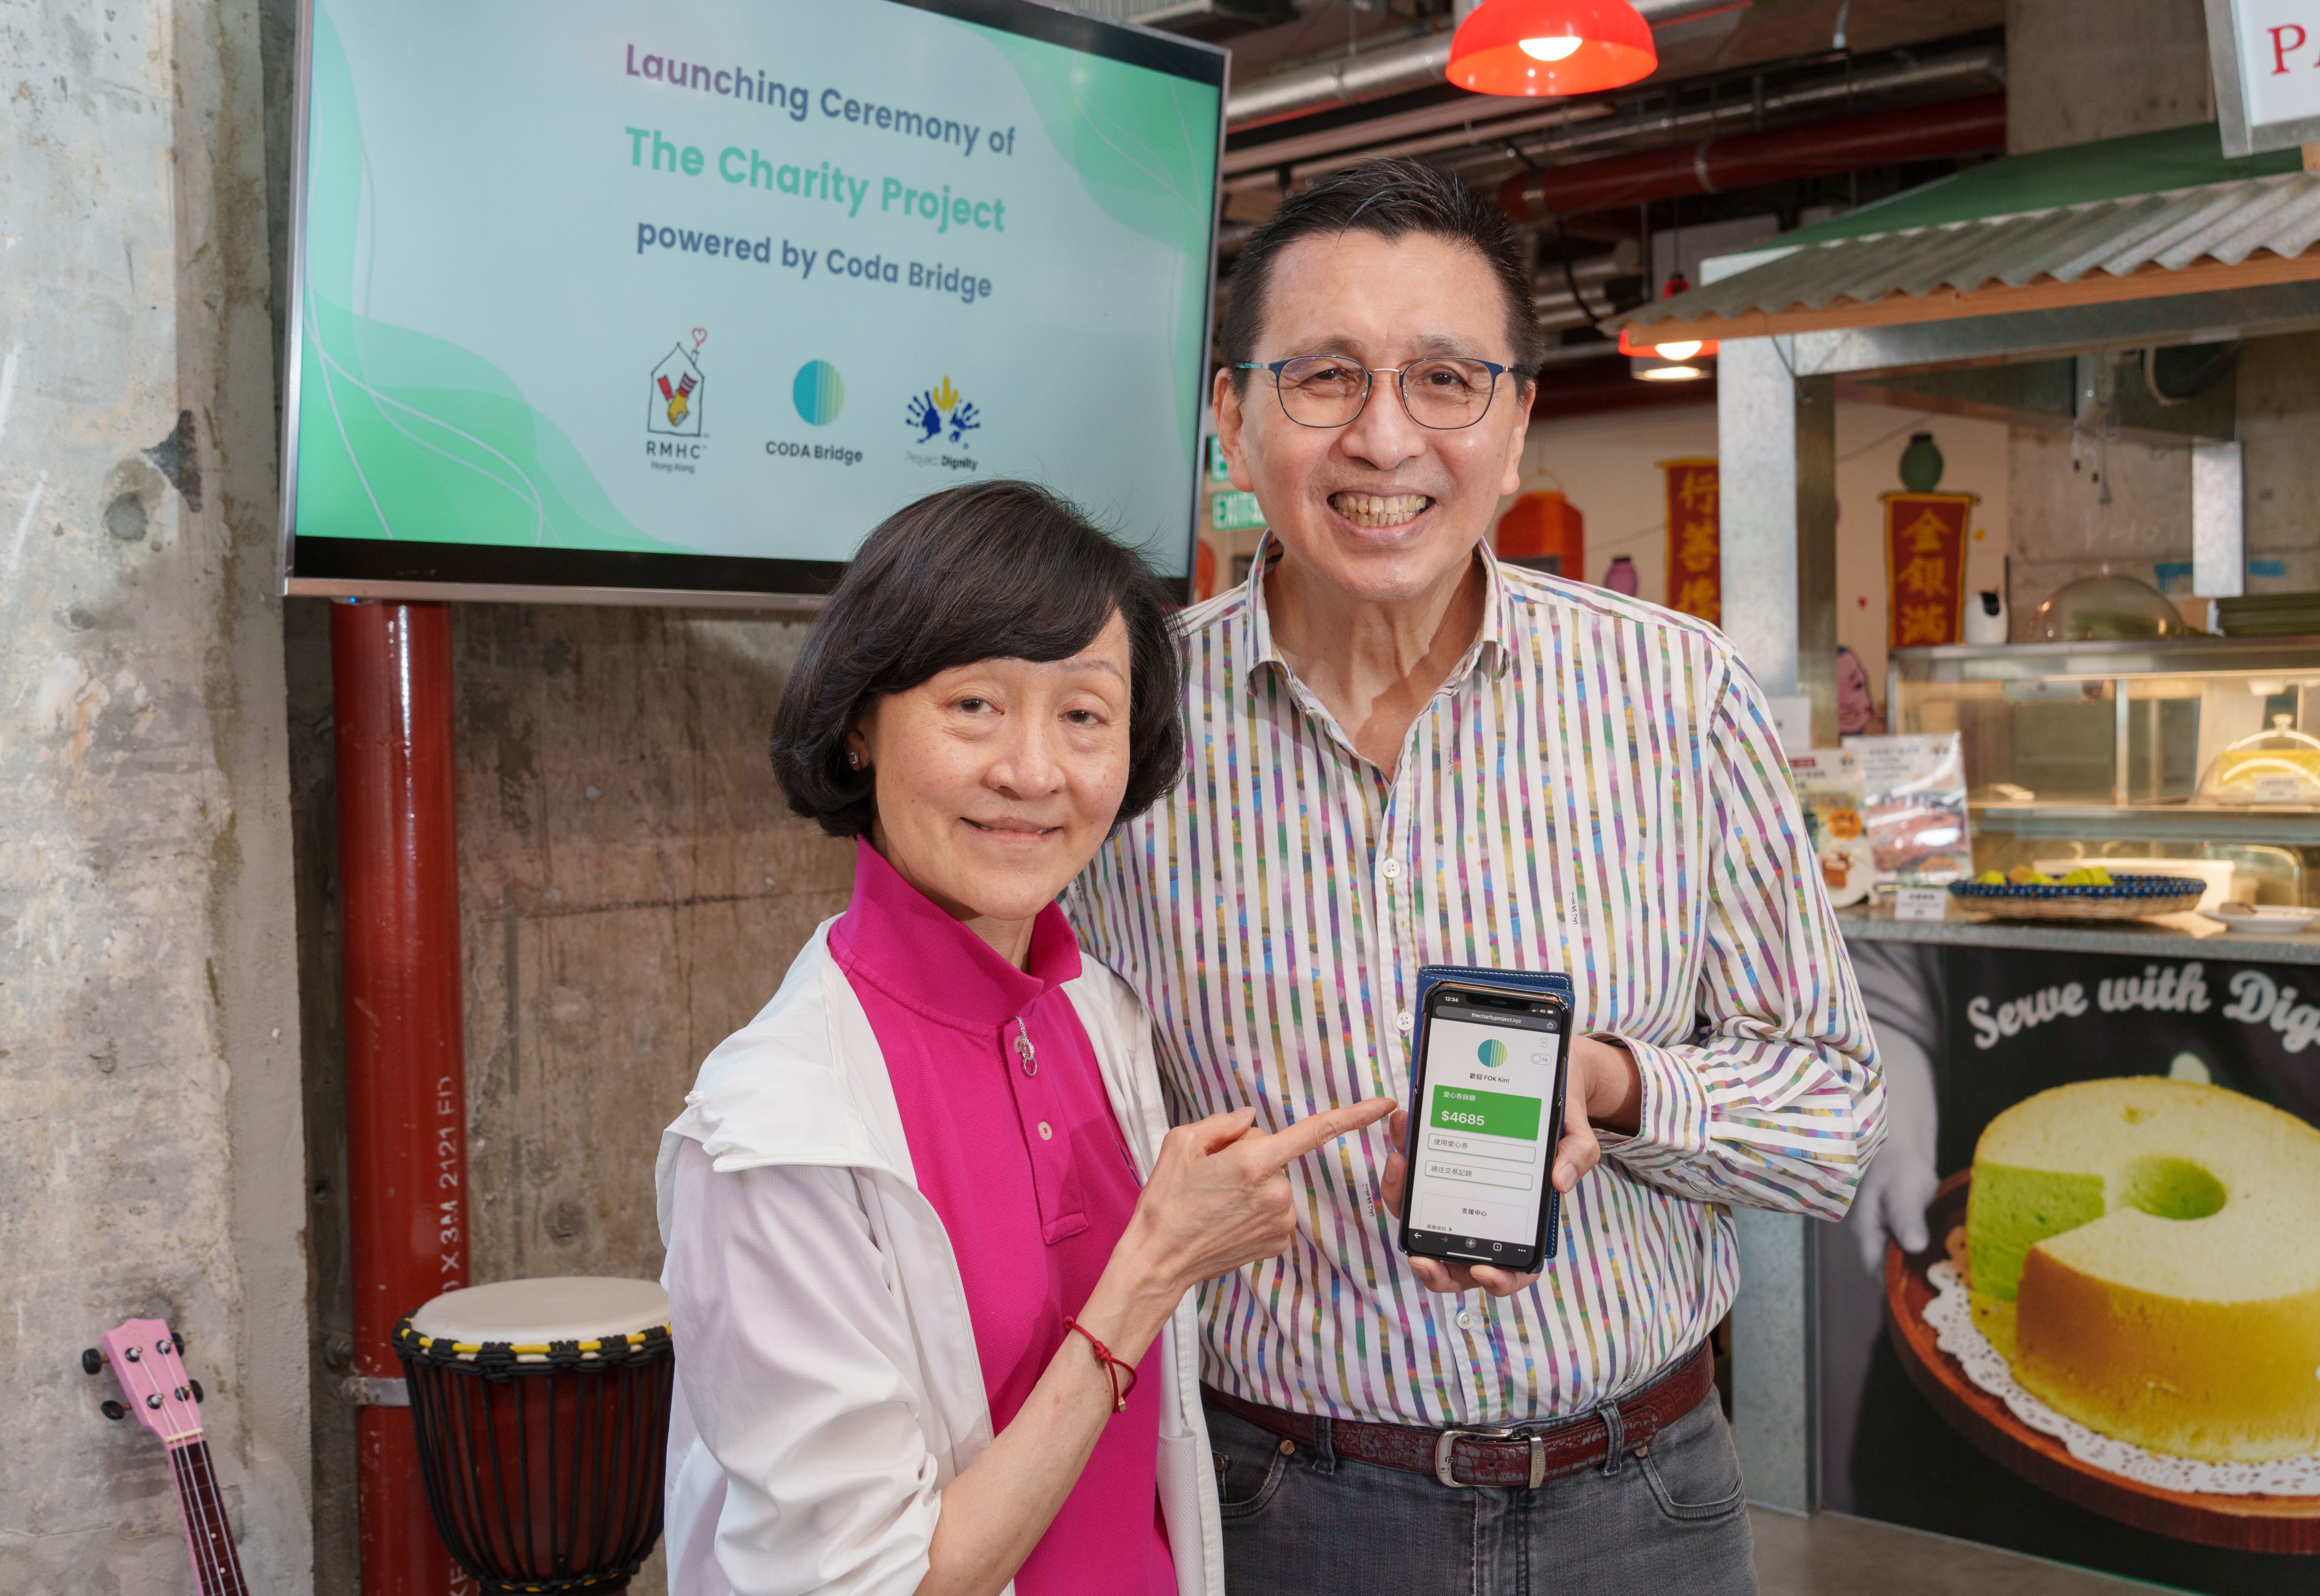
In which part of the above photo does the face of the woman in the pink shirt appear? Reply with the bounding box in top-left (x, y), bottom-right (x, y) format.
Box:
top-left (847, 615), bottom-right (1130, 923)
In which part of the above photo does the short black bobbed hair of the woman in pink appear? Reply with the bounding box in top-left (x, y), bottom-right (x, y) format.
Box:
top-left (773, 480), bottom-right (1183, 838)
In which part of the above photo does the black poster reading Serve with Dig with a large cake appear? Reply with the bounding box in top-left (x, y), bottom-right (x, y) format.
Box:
top-left (1819, 942), bottom-right (2320, 1596)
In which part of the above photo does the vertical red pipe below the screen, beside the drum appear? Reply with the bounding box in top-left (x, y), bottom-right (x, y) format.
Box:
top-left (329, 603), bottom-right (471, 1596)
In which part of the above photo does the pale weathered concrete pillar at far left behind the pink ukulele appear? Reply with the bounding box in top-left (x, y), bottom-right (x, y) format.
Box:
top-left (0, 0), bottom-right (311, 1596)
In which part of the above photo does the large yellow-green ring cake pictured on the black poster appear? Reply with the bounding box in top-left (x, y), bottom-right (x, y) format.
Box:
top-left (1965, 1077), bottom-right (2320, 1461)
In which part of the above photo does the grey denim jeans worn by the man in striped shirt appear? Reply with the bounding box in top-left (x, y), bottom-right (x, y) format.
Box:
top-left (1208, 1392), bottom-right (1756, 1596)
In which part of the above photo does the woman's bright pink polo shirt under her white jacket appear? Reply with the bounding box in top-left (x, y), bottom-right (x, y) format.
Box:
top-left (830, 842), bottom-right (1176, 1596)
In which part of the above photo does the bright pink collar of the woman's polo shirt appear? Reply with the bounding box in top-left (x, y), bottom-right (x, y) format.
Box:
top-left (830, 838), bottom-right (1081, 1030)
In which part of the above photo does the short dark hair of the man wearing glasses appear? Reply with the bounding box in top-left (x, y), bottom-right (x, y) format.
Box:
top-left (1218, 160), bottom-right (1547, 387)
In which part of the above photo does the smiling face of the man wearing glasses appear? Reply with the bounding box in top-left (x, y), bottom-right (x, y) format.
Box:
top-left (1216, 232), bottom-right (1531, 603)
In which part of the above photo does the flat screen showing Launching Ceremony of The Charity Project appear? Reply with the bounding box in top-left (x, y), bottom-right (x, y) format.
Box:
top-left (283, 0), bottom-right (1225, 603)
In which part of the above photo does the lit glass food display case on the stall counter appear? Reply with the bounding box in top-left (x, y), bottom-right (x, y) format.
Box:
top-left (1889, 638), bottom-right (2320, 905)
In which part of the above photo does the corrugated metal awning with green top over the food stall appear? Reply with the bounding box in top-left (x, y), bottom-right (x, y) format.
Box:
top-left (1626, 125), bottom-right (2320, 343)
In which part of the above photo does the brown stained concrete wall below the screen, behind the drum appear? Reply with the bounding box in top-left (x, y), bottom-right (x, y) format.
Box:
top-left (288, 599), bottom-right (854, 1596)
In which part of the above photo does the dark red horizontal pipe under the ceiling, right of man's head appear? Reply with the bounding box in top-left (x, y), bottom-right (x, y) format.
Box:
top-left (1499, 95), bottom-right (2007, 220)
